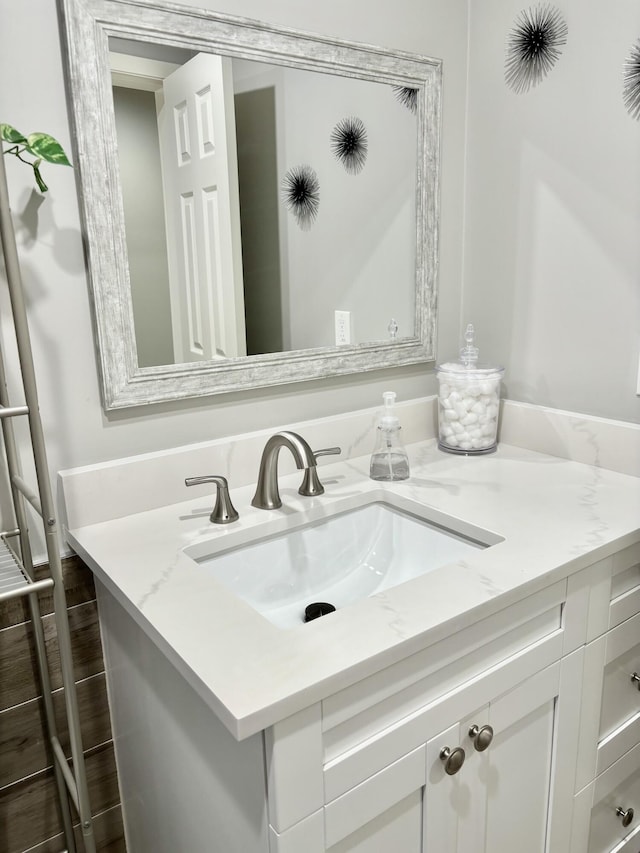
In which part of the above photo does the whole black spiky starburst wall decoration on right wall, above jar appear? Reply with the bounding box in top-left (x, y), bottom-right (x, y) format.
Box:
top-left (505, 5), bottom-right (568, 94)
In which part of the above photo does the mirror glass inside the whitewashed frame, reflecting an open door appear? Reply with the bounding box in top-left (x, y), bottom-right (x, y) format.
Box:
top-left (109, 37), bottom-right (418, 368)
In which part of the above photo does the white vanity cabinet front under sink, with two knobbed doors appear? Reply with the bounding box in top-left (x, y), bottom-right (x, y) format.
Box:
top-left (266, 582), bottom-right (585, 853)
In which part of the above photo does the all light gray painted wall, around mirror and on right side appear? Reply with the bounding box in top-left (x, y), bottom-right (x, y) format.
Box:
top-left (6, 0), bottom-right (640, 552)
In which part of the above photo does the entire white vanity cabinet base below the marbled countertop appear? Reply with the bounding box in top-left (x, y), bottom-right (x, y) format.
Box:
top-left (97, 544), bottom-right (640, 853)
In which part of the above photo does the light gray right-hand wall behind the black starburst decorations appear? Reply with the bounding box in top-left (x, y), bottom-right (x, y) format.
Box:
top-left (463, 0), bottom-right (640, 422)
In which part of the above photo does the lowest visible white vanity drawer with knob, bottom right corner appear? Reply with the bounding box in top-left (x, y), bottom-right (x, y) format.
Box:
top-left (588, 744), bottom-right (640, 853)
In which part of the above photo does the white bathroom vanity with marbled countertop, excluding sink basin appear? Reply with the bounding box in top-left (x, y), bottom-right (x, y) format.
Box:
top-left (61, 401), bottom-right (640, 853)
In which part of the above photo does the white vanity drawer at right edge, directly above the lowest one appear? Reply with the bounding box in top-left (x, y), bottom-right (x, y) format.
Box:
top-left (598, 614), bottom-right (640, 741)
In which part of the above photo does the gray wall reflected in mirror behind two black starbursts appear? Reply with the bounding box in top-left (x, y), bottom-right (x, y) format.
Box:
top-left (283, 72), bottom-right (417, 349)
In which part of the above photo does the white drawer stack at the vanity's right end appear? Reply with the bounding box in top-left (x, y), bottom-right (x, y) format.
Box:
top-left (571, 544), bottom-right (640, 853)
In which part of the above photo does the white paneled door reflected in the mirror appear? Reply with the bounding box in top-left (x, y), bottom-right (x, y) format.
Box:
top-left (158, 54), bottom-right (246, 362)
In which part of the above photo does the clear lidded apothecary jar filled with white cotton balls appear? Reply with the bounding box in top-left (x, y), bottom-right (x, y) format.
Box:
top-left (436, 324), bottom-right (504, 455)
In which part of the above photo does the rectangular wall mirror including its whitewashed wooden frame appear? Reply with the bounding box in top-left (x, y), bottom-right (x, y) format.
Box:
top-left (59, 0), bottom-right (441, 410)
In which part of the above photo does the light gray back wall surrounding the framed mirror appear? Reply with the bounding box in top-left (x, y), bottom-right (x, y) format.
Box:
top-left (0, 0), bottom-right (466, 502)
